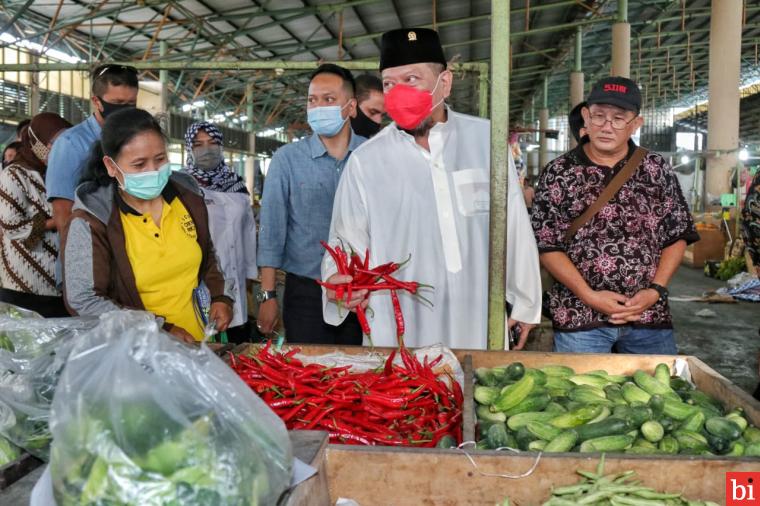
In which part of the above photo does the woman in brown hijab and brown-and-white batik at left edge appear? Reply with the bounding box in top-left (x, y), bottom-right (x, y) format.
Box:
top-left (0, 112), bottom-right (71, 317)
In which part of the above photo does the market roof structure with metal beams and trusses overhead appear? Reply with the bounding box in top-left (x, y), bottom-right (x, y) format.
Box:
top-left (0, 0), bottom-right (760, 133)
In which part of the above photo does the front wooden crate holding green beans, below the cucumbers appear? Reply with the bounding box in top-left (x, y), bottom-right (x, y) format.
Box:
top-left (327, 445), bottom-right (760, 506)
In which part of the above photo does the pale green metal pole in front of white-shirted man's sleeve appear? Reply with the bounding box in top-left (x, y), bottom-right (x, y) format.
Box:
top-left (488, 0), bottom-right (510, 350)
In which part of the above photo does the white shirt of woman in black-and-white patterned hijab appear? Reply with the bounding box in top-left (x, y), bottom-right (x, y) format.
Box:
top-left (203, 188), bottom-right (259, 327)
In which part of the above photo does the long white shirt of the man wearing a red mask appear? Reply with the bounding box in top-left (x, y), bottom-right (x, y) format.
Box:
top-left (322, 109), bottom-right (541, 349)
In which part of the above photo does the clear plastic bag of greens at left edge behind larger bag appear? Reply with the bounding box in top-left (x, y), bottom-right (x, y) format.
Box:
top-left (0, 304), bottom-right (98, 460)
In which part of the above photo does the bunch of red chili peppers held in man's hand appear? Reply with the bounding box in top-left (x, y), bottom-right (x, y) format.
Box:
top-left (317, 241), bottom-right (432, 348)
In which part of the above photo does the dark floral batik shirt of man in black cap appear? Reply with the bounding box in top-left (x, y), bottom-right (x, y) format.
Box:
top-left (532, 141), bottom-right (699, 332)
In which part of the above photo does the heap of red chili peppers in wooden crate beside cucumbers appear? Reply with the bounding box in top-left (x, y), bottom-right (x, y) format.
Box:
top-left (230, 341), bottom-right (463, 447)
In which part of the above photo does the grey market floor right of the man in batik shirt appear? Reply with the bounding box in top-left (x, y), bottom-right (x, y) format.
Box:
top-left (670, 266), bottom-right (760, 393)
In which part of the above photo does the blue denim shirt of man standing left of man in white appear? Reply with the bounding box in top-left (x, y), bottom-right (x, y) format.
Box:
top-left (257, 132), bottom-right (366, 279)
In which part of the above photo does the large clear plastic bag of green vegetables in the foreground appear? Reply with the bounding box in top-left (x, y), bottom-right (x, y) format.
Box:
top-left (50, 311), bottom-right (292, 506)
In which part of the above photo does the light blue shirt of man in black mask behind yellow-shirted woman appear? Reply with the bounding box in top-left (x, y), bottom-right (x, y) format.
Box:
top-left (45, 116), bottom-right (101, 202)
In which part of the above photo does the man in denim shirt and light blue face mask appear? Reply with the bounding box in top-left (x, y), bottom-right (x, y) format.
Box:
top-left (257, 64), bottom-right (365, 345)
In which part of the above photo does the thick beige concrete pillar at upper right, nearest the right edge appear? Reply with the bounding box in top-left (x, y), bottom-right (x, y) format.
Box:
top-left (705, 0), bottom-right (743, 203)
